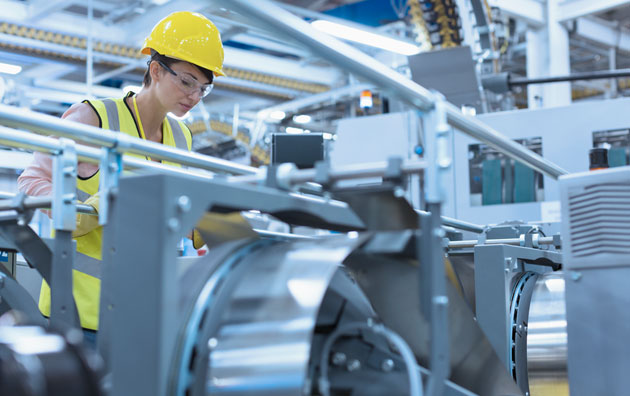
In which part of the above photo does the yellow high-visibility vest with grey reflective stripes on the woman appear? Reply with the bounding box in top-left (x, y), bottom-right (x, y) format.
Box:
top-left (39, 92), bottom-right (192, 330)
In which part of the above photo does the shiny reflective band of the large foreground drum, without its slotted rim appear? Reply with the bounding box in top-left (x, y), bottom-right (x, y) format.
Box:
top-left (206, 237), bottom-right (368, 395)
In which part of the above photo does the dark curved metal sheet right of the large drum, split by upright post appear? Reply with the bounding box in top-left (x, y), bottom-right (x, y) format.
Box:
top-left (344, 253), bottom-right (522, 396)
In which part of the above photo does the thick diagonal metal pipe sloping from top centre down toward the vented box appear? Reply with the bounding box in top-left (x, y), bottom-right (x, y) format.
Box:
top-left (223, 0), bottom-right (567, 179)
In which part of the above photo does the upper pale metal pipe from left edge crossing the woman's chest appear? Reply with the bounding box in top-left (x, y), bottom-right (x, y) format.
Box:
top-left (0, 105), bottom-right (256, 175)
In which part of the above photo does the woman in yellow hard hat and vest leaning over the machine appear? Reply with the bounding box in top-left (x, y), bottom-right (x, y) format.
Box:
top-left (18, 12), bottom-right (225, 344)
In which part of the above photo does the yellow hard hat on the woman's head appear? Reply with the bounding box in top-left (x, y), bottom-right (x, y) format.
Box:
top-left (142, 11), bottom-right (225, 76)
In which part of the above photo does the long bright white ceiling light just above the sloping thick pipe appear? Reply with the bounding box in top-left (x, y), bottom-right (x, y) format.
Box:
top-left (311, 19), bottom-right (421, 56)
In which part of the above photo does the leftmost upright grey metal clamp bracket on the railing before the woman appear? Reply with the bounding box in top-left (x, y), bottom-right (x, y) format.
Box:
top-left (52, 138), bottom-right (77, 231)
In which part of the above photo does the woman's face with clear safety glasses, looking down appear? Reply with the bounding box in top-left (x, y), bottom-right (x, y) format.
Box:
top-left (158, 62), bottom-right (210, 117)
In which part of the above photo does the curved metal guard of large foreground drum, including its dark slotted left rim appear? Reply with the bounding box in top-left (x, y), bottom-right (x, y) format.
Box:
top-left (178, 236), bottom-right (364, 395)
